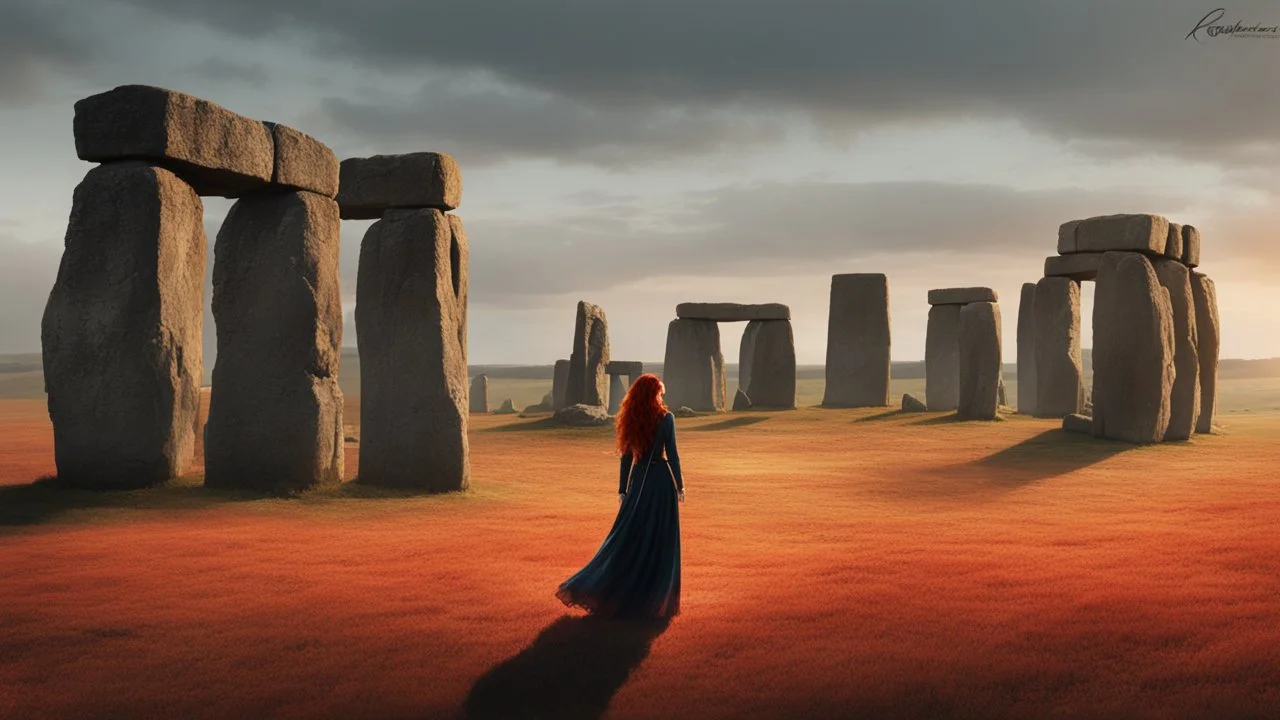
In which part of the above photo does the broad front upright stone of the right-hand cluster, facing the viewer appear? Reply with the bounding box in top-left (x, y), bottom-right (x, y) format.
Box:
top-left (1090, 252), bottom-right (1174, 443)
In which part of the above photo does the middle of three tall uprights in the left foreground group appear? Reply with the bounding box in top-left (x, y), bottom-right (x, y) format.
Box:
top-left (205, 191), bottom-right (345, 491)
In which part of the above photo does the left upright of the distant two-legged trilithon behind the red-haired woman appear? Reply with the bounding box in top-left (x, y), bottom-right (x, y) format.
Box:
top-left (662, 318), bottom-right (726, 411)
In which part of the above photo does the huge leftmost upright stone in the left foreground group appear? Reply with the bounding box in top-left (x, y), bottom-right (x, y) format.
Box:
top-left (41, 163), bottom-right (206, 488)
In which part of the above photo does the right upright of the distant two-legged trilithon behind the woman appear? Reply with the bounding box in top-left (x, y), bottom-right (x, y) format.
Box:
top-left (739, 320), bottom-right (796, 410)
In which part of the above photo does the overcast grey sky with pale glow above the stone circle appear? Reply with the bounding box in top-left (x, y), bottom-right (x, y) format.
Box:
top-left (0, 0), bottom-right (1280, 364)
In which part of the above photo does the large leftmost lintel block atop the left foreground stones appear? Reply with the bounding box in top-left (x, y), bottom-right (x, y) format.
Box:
top-left (73, 85), bottom-right (275, 197)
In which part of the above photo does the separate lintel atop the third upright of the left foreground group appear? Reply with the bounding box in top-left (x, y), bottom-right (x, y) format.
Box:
top-left (338, 152), bottom-right (462, 220)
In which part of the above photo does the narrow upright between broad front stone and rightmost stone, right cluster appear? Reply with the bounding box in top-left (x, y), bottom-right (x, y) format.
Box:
top-left (1152, 260), bottom-right (1201, 442)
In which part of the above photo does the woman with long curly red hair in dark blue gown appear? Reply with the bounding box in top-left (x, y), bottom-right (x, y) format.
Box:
top-left (556, 373), bottom-right (685, 618)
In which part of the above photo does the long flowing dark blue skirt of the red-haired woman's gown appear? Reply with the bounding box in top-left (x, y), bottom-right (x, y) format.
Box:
top-left (556, 460), bottom-right (680, 618)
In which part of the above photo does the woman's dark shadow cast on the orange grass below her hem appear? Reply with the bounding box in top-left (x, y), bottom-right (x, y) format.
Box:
top-left (462, 615), bottom-right (669, 720)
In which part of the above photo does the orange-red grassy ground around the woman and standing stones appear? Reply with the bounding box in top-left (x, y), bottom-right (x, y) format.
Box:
top-left (0, 401), bottom-right (1280, 720)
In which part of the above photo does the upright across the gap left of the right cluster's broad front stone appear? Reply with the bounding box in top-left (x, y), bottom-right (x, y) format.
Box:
top-left (1027, 278), bottom-right (1084, 418)
